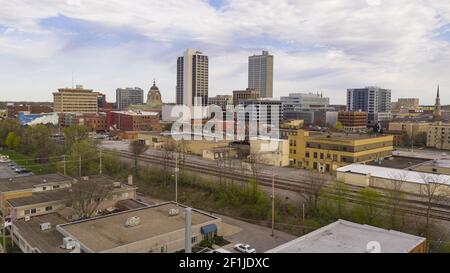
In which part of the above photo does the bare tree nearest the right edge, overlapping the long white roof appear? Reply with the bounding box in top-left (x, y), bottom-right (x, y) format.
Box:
top-left (420, 173), bottom-right (449, 237)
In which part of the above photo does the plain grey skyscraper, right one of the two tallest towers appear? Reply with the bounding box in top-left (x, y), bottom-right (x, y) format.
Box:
top-left (248, 51), bottom-right (273, 98)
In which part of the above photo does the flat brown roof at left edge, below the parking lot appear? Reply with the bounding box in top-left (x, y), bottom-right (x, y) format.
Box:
top-left (0, 173), bottom-right (73, 192)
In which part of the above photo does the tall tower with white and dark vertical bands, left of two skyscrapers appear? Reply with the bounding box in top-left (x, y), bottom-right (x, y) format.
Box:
top-left (177, 49), bottom-right (209, 107)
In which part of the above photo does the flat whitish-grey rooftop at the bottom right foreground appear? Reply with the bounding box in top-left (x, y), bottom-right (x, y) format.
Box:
top-left (267, 220), bottom-right (426, 253)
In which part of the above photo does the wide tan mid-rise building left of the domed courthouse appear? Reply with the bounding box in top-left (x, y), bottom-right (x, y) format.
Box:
top-left (53, 85), bottom-right (99, 113)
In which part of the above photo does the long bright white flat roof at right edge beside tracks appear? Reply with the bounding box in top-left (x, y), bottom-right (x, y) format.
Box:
top-left (336, 164), bottom-right (450, 185)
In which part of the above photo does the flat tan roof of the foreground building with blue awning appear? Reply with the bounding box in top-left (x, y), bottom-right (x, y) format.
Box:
top-left (58, 203), bottom-right (218, 252)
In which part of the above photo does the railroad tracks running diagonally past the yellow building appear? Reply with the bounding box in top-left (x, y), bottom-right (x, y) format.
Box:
top-left (105, 151), bottom-right (450, 221)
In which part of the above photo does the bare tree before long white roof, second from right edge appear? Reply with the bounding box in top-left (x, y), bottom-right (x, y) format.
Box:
top-left (387, 171), bottom-right (408, 229)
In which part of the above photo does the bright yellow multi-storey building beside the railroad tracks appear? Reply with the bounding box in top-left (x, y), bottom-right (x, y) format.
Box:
top-left (289, 130), bottom-right (393, 173)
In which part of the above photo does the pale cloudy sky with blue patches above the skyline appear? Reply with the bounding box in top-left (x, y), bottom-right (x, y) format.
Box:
top-left (0, 0), bottom-right (450, 104)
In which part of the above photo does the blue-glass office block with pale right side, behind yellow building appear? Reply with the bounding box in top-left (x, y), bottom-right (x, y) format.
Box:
top-left (347, 86), bottom-right (391, 126)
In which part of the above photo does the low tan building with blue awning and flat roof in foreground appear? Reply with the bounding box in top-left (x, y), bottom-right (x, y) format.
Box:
top-left (57, 202), bottom-right (221, 253)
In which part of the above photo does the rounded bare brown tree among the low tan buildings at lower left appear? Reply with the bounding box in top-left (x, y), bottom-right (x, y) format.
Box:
top-left (68, 179), bottom-right (113, 219)
